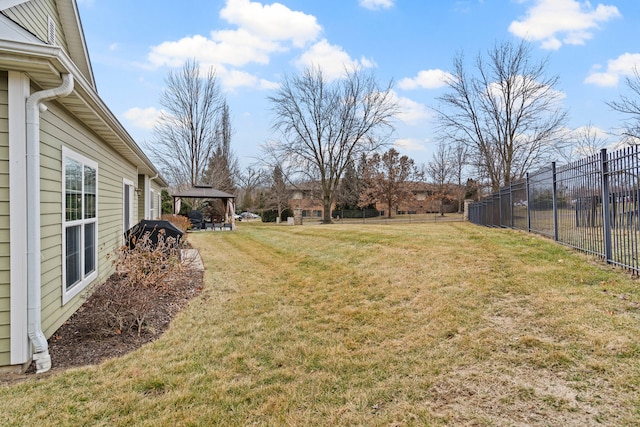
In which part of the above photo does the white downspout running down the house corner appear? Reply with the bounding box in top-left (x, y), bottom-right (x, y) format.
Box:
top-left (26, 74), bottom-right (73, 373)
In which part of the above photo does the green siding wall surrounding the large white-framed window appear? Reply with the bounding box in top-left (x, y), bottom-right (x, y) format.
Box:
top-left (40, 103), bottom-right (137, 337)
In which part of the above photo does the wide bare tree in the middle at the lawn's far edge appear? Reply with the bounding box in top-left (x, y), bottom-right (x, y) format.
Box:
top-left (266, 67), bottom-right (397, 223)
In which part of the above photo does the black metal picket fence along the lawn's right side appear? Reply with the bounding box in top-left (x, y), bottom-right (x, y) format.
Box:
top-left (469, 146), bottom-right (640, 274)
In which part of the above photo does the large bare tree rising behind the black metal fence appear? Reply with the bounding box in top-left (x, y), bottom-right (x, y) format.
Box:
top-left (437, 41), bottom-right (566, 190)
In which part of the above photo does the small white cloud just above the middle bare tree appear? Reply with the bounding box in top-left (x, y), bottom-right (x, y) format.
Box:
top-left (295, 40), bottom-right (375, 80)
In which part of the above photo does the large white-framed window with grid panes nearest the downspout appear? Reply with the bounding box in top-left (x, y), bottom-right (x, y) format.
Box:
top-left (62, 148), bottom-right (98, 303)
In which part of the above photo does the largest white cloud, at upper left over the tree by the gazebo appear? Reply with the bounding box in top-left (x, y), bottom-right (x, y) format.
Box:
top-left (147, 0), bottom-right (322, 88)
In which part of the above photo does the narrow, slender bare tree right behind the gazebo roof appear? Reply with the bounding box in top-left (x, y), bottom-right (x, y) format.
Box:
top-left (204, 102), bottom-right (240, 193)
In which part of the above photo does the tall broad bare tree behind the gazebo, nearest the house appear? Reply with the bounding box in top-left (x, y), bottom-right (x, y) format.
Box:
top-left (149, 60), bottom-right (222, 186)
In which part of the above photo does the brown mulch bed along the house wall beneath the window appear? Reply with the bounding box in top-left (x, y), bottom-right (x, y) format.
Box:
top-left (0, 266), bottom-right (203, 385)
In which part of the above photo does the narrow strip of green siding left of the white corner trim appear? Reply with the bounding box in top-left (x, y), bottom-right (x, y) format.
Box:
top-left (0, 71), bottom-right (11, 366)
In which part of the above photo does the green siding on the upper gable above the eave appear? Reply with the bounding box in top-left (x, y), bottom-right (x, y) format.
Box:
top-left (3, 0), bottom-right (69, 52)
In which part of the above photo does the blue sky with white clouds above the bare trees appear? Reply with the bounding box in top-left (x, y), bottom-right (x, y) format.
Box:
top-left (78, 0), bottom-right (640, 171)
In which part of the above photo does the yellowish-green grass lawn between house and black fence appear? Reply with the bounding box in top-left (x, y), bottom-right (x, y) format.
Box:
top-left (0, 222), bottom-right (640, 426)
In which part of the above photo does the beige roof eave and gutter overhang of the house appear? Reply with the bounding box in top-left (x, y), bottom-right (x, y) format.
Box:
top-left (0, 0), bottom-right (168, 187)
